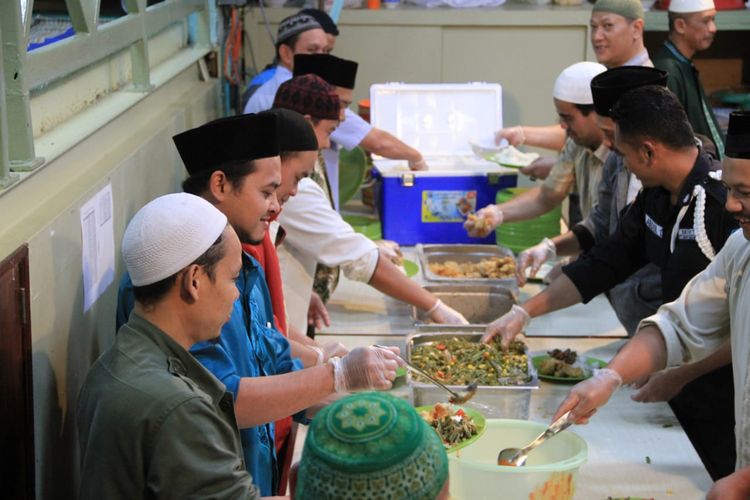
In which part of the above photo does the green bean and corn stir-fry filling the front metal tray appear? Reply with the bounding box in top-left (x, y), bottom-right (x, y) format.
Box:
top-left (411, 337), bottom-right (531, 386)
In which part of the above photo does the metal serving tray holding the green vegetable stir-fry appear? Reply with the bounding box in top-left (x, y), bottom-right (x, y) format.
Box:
top-left (406, 327), bottom-right (539, 420)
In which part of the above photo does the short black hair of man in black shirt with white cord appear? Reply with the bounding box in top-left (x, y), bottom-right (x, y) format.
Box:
top-left (610, 85), bottom-right (695, 150)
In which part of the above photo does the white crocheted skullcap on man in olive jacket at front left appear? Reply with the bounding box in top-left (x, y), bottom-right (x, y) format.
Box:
top-left (122, 193), bottom-right (227, 286)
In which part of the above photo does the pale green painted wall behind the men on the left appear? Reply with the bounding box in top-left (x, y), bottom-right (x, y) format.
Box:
top-left (0, 65), bottom-right (219, 498)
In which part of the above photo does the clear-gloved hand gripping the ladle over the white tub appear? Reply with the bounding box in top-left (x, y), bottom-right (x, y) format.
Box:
top-left (553, 368), bottom-right (622, 424)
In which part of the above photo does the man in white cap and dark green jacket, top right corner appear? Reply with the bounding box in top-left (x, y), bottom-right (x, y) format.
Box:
top-left (654, 0), bottom-right (724, 155)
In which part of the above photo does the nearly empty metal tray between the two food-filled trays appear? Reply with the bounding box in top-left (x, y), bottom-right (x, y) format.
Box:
top-left (412, 283), bottom-right (518, 331)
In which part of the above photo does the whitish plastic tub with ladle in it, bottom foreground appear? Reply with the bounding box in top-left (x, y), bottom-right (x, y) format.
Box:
top-left (448, 419), bottom-right (588, 500)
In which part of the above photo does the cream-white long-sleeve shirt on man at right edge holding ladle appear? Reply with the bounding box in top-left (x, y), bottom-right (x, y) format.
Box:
top-left (639, 230), bottom-right (750, 469)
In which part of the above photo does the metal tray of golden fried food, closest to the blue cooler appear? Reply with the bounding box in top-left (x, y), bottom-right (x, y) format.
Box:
top-left (417, 244), bottom-right (518, 289)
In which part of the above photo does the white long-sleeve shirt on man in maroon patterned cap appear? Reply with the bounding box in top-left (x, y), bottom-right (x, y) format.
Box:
top-left (278, 179), bottom-right (379, 332)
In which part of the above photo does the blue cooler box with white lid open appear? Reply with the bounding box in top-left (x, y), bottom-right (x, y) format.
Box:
top-left (370, 83), bottom-right (518, 245)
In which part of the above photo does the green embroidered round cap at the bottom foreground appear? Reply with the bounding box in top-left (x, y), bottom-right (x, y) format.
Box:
top-left (294, 392), bottom-right (448, 500)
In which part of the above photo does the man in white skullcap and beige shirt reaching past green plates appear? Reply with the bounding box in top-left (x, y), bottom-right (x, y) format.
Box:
top-left (464, 62), bottom-right (609, 282)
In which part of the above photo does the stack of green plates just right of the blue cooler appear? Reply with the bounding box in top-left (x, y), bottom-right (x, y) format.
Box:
top-left (495, 188), bottom-right (560, 253)
